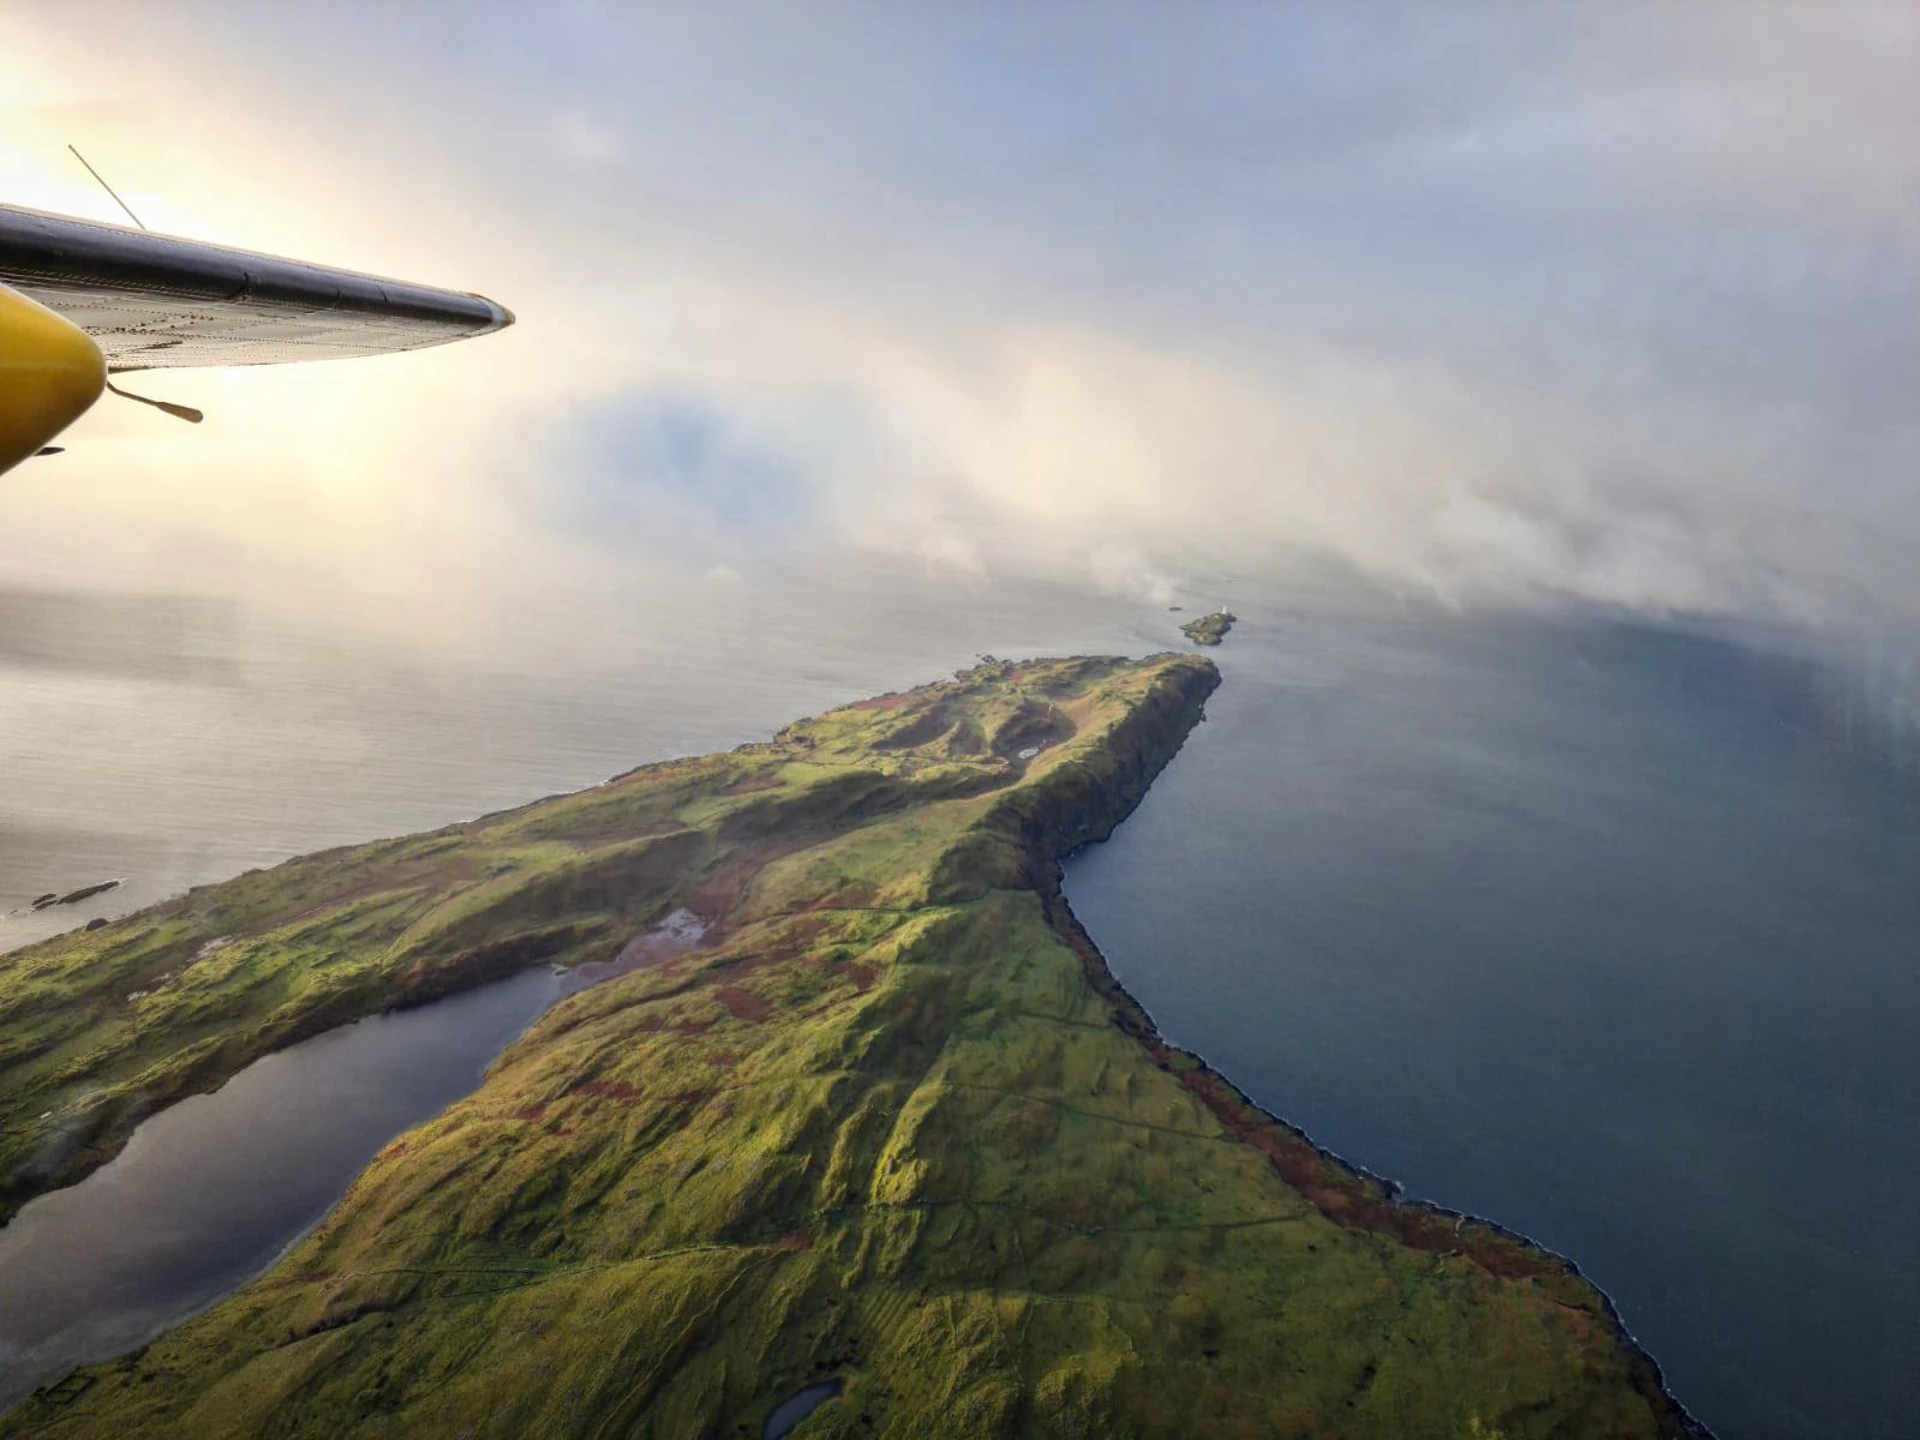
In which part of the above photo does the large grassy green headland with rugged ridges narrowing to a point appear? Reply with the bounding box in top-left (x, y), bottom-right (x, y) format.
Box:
top-left (0, 655), bottom-right (1697, 1440)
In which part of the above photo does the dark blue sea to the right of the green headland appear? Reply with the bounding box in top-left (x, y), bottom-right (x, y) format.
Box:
top-left (1068, 603), bottom-right (1920, 1440)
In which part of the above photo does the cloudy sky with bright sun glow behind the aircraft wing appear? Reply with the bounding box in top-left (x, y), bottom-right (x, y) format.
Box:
top-left (0, 0), bottom-right (1920, 643)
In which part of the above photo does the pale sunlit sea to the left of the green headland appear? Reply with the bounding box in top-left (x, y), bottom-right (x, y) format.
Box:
top-left (0, 559), bottom-right (1183, 948)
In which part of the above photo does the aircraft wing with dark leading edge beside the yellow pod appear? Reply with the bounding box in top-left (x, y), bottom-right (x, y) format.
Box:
top-left (0, 205), bottom-right (513, 372)
